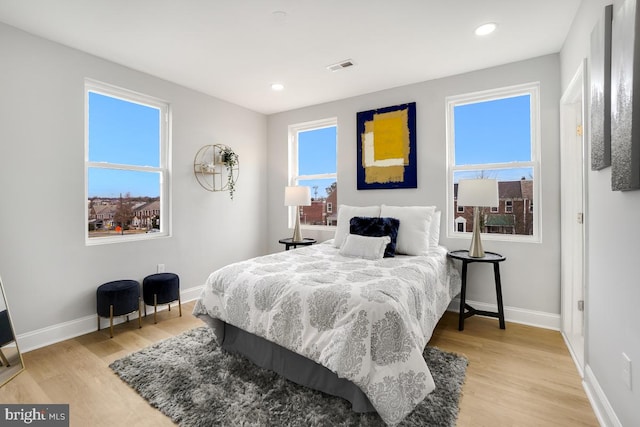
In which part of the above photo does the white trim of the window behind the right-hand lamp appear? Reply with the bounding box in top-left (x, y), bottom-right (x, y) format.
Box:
top-left (445, 82), bottom-right (542, 243)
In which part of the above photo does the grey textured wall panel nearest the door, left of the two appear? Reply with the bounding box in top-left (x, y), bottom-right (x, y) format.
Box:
top-left (589, 5), bottom-right (613, 170)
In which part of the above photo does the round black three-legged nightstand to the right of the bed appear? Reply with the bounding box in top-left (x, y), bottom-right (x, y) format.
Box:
top-left (447, 250), bottom-right (507, 331)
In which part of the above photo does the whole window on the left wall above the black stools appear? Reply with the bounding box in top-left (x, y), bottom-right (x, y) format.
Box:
top-left (85, 80), bottom-right (169, 245)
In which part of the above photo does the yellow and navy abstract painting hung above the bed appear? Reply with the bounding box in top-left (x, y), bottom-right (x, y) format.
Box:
top-left (357, 102), bottom-right (418, 190)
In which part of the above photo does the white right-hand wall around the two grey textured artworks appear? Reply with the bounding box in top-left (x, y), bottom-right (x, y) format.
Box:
top-left (560, 0), bottom-right (640, 426)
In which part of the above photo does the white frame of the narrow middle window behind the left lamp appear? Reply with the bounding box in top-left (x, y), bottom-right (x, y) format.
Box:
top-left (287, 117), bottom-right (339, 230)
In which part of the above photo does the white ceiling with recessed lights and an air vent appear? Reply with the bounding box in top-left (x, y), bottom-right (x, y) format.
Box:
top-left (0, 0), bottom-right (581, 114)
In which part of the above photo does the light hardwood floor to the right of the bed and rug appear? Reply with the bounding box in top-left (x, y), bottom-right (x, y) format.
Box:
top-left (429, 312), bottom-right (599, 427)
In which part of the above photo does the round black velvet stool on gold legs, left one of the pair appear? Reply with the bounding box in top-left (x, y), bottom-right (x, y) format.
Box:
top-left (96, 280), bottom-right (142, 338)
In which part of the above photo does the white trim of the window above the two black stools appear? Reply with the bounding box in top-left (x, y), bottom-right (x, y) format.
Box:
top-left (83, 78), bottom-right (171, 246)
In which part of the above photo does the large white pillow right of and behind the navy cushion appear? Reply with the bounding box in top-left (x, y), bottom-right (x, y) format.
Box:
top-left (380, 205), bottom-right (436, 255)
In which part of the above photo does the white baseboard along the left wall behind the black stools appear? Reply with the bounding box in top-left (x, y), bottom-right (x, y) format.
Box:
top-left (17, 286), bottom-right (202, 353)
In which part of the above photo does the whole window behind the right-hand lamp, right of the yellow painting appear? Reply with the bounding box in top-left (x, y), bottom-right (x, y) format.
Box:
top-left (447, 83), bottom-right (540, 241)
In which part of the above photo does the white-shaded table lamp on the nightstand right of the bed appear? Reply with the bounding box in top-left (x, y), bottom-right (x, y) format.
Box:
top-left (458, 179), bottom-right (498, 258)
